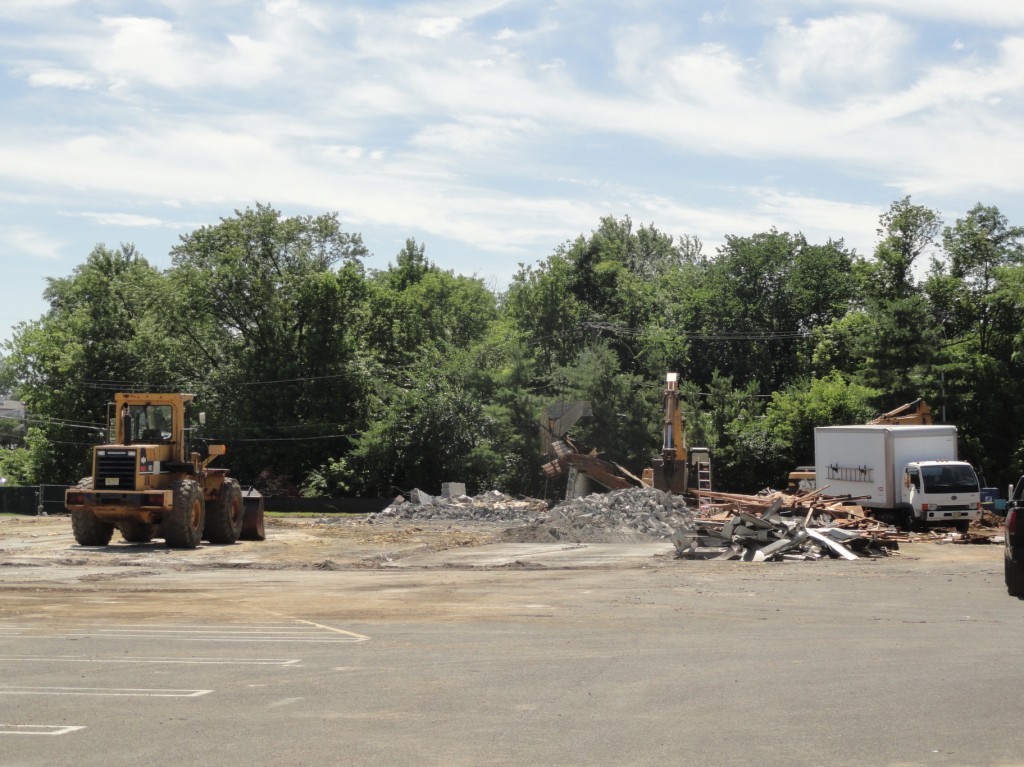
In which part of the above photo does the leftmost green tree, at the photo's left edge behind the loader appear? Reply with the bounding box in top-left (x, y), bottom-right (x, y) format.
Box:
top-left (3, 245), bottom-right (169, 482)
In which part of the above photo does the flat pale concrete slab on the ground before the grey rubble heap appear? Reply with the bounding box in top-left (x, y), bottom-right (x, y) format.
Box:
top-left (387, 541), bottom-right (674, 568)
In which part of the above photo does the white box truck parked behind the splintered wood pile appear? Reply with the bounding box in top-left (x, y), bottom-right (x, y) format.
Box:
top-left (814, 425), bottom-right (981, 531)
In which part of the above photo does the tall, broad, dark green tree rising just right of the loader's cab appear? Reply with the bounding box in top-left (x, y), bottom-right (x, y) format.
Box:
top-left (167, 204), bottom-right (375, 484)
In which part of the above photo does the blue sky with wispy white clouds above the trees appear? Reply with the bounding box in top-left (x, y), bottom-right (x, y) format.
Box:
top-left (0, 0), bottom-right (1024, 340)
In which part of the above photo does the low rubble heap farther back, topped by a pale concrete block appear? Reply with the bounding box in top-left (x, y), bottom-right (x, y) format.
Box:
top-left (367, 489), bottom-right (548, 524)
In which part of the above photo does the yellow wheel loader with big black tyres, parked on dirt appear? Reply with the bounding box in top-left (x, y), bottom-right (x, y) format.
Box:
top-left (65, 394), bottom-right (264, 549)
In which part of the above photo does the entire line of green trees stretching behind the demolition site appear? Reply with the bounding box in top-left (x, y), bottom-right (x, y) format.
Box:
top-left (0, 198), bottom-right (1024, 497)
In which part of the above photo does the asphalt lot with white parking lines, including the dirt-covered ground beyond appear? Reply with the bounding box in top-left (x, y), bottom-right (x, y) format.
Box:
top-left (0, 514), bottom-right (1024, 767)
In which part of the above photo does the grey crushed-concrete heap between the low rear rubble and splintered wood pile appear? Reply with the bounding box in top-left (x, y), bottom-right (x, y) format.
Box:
top-left (503, 487), bottom-right (693, 543)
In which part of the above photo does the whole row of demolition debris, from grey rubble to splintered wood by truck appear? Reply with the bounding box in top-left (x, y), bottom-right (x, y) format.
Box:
top-left (366, 487), bottom-right (907, 561)
